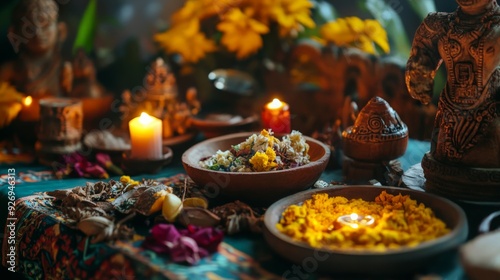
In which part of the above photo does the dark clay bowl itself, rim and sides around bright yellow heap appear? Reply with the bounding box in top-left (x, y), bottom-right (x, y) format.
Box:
top-left (264, 186), bottom-right (468, 278)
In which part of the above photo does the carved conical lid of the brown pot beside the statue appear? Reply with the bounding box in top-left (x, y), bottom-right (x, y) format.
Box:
top-left (342, 96), bottom-right (408, 142)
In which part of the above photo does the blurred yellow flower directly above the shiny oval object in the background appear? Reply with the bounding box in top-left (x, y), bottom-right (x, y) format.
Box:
top-left (217, 8), bottom-right (269, 59)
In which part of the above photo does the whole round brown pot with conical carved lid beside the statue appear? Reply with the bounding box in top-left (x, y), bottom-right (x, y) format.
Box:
top-left (342, 96), bottom-right (408, 162)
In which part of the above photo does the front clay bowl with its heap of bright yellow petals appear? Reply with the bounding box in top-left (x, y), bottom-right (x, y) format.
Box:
top-left (264, 186), bottom-right (468, 277)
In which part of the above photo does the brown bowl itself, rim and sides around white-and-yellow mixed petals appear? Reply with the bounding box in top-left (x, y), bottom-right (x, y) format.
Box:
top-left (182, 132), bottom-right (330, 206)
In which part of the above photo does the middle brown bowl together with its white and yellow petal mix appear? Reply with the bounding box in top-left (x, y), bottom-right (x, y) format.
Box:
top-left (182, 130), bottom-right (330, 206)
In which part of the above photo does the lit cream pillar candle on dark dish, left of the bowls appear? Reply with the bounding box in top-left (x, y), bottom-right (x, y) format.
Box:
top-left (129, 112), bottom-right (163, 159)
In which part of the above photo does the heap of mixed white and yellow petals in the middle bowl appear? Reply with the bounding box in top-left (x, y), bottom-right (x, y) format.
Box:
top-left (200, 129), bottom-right (309, 172)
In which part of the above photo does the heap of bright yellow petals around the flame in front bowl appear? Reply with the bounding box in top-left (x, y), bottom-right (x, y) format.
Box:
top-left (276, 191), bottom-right (449, 251)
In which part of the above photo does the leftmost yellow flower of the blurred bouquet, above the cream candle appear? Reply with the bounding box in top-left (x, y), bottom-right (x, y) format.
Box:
top-left (155, 19), bottom-right (217, 62)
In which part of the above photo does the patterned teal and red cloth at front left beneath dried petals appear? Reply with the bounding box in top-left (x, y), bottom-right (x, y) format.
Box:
top-left (2, 182), bottom-right (279, 279)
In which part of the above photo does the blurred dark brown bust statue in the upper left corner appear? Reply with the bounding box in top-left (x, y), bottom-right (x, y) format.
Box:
top-left (0, 0), bottom-right (72, 127)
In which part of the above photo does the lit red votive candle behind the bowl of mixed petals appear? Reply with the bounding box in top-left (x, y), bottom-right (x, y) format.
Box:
top-left (262, 98), bottom-right (291, 133)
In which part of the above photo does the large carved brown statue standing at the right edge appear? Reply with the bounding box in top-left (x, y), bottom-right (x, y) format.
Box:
top-left (406, 0), bottom-right (500, 201)
